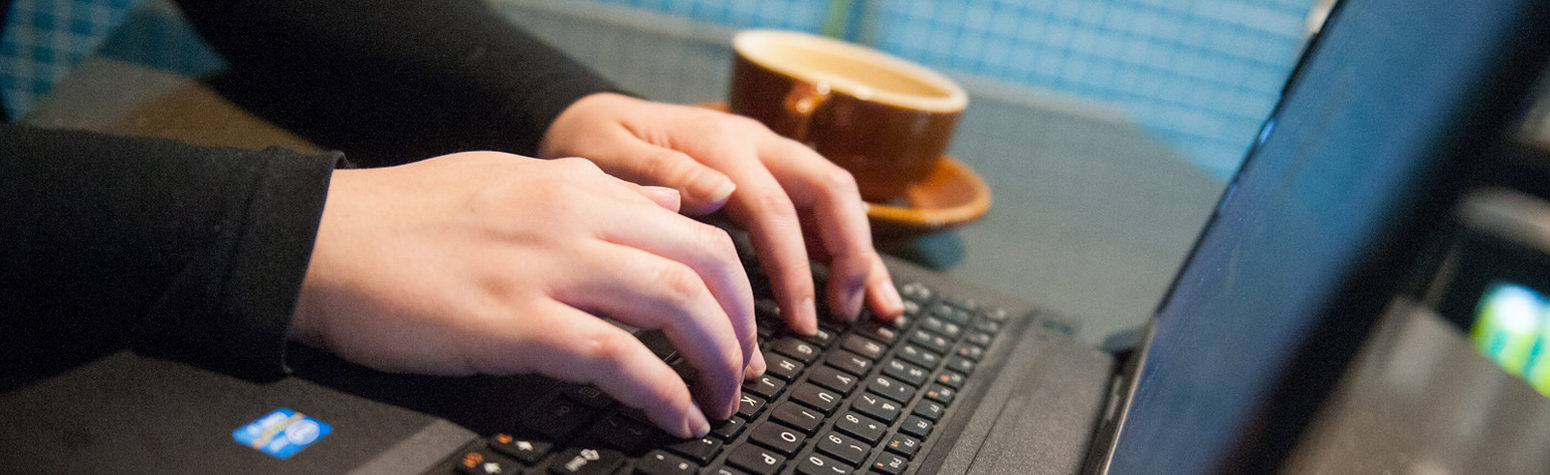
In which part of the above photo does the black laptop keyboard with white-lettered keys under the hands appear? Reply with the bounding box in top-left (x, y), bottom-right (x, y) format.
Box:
top-left (453, 274), bottom-right (1006, 473)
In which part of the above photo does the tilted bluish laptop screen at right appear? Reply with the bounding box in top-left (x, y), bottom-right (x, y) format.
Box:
top-left (1110, 0), bottom-right (1545, 473)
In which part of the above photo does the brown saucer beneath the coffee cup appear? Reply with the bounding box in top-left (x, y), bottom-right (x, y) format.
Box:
top-left (866, 155), bottom-right (990, 238)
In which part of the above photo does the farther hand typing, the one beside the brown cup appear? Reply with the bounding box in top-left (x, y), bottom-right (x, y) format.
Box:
top-left (538, 93), bottom-right (904, 334)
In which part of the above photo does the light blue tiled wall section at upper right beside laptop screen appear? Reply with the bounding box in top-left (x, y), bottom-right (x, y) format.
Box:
top-left (876, 0), bottom-right (1311, 177)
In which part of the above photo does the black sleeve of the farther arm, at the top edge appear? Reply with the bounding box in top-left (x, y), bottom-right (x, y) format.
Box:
top-left (178, 0), bottom-right (617, 166)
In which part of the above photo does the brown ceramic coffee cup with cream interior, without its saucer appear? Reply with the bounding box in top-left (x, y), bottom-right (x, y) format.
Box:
top-left (729, 29), bottom-right (969, 203)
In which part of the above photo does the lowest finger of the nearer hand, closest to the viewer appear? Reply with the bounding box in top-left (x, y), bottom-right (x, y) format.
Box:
top-left (507, 303), bottom-right (710, 438)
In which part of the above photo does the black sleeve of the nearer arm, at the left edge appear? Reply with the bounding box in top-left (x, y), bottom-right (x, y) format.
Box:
top-left (0, 126), bottom-right (341, 383)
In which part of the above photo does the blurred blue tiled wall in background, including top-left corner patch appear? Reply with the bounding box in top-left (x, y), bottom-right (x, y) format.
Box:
top-left (0, 0), bottom-right (1314, 179)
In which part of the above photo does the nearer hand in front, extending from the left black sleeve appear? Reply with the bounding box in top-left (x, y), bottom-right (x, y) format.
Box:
top-left (291, 152), bottom-right (764, 436)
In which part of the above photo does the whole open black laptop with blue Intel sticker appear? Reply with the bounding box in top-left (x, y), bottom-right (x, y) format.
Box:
top-left (0, 0), bottom-right (1550, 473)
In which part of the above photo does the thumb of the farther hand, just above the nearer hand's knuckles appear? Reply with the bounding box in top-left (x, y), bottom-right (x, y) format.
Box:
top-left (595, 128), bottom-right (736, 214)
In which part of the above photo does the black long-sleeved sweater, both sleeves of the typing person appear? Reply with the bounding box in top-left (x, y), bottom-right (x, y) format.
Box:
top-left (0, 0), bottom-right (614, 388)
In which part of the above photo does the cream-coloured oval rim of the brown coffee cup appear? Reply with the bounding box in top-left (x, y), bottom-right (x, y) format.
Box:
top-left (732, 29), bottom-right (969, 112)
